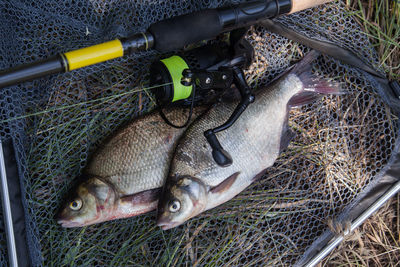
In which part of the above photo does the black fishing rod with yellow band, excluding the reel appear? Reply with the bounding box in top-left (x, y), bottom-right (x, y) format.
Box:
top-left (0, 0), bottom-right (332, 88)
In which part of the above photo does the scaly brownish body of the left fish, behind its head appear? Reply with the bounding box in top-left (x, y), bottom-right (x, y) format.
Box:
top-left (84, 108), bottom-right (201, 195)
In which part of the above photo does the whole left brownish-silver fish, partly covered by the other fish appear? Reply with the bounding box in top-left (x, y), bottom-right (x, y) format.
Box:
top-left (57, 107), bottom-right (205, 227)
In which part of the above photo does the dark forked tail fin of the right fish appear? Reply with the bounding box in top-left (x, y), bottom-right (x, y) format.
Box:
top-left (289, 50), bottom-right (343, 107)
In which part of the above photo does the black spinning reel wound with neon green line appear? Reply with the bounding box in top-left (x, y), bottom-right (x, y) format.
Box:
top-left (150, 29), bottom-right (254, 167)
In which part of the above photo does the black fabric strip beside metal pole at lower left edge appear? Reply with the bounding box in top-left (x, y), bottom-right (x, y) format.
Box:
top-left (2, 139), bottom-right (30, 267)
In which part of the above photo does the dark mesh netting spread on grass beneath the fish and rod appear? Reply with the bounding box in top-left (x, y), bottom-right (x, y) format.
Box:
top-left (0, 0), bottom-right (398, 266)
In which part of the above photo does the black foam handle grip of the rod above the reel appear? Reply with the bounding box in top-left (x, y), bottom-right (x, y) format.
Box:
top-left (148, 0), bottom-right (291, 53)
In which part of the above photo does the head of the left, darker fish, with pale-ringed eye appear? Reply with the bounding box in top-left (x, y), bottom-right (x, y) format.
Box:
top-left (56, 176), bottom-right (116, 228)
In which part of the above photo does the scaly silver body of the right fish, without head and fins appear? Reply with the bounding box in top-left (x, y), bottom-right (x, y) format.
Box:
top-left (171, 74), bottom-right (302, 189)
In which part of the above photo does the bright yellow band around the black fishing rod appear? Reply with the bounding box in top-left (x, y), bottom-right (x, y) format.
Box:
top-left (64, 39), bottom-right (124, 71)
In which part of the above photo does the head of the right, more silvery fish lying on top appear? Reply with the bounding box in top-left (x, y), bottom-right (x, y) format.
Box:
top-left (157, 176), bottom-right (207, 230)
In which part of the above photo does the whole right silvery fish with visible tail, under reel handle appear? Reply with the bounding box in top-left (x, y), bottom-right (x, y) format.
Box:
top-left (157, 51), bottom-right (339, 230)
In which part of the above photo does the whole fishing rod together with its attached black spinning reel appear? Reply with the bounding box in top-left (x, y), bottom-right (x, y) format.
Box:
top-left (0, 0), bottom-right (332, 167)
